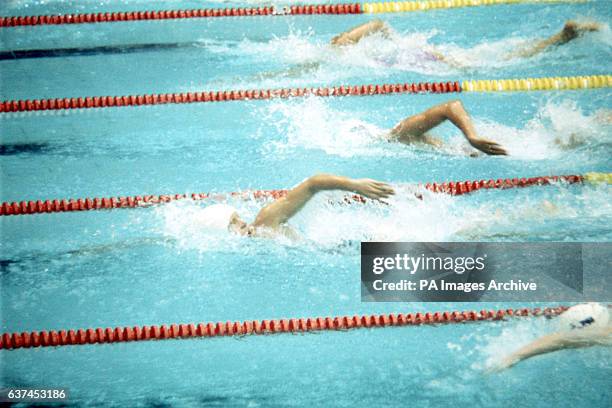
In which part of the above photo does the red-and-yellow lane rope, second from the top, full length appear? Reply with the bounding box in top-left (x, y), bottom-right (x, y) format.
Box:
top-left (0, 75), bottom-right (612, 113)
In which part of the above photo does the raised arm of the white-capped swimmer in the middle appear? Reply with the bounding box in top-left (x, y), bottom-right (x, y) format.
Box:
top-left (253, 174), bottom-right (394, 228)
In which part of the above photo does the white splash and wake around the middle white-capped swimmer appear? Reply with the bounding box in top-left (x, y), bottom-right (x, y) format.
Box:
top-left (154, 184), bottom-right (612, 253)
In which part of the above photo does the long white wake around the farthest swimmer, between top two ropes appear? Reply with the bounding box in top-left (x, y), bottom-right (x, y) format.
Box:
top-left (202, 22), bottom-right (612, 87)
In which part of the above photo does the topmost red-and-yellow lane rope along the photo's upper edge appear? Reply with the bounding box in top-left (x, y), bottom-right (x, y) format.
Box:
top-left (0, 0), bottom-right (586, 27)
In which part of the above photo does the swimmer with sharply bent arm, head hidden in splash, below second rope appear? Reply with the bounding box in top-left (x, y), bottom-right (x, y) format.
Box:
top-left (387, 100), bottom-right (508, 156)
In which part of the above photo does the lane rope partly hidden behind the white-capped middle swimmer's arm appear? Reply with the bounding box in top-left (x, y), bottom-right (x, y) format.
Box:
top-left (0, 173), bottom-right (612, 216)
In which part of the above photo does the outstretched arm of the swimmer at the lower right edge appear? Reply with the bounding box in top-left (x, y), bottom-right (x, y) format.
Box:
top-left (496, 327), bottom-right (612, 371)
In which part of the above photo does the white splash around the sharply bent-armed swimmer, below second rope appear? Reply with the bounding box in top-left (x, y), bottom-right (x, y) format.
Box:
top-left (254, 97), bottom-right (612, 162)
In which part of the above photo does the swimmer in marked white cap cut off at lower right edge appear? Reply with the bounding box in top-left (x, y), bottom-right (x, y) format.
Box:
top-left (493, 303), bottom-right (612, 371)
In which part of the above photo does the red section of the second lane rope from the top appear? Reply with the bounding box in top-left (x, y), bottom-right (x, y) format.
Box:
top-left (0, 82), bottom-right (461, 113)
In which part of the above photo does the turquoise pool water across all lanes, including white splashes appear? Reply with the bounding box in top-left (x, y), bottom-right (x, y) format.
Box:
top-left (0, 1), bottom-right (612, 406)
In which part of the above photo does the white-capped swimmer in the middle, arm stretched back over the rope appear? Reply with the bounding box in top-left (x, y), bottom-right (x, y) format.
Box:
top-left (194, 174), bottom-right (395, 239)
